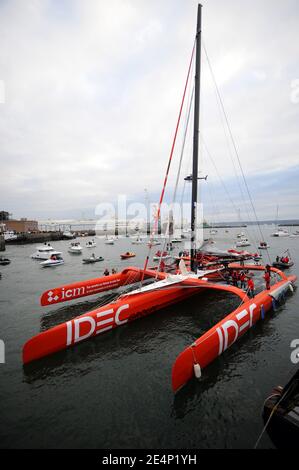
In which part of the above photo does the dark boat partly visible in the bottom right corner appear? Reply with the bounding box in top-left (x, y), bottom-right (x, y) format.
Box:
top-left (263, 369), bottom-right (299, 449)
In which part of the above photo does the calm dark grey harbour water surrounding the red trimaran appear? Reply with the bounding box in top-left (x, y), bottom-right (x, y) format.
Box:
top-left (0, 227), bottom-right (299, 449)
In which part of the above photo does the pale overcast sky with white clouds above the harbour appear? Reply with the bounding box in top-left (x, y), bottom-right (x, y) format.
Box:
top-left (0, 0), bottom-right (299, 220)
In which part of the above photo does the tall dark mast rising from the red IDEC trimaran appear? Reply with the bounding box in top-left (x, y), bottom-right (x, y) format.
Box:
top-left (191, 4), bottom-right (202, 272)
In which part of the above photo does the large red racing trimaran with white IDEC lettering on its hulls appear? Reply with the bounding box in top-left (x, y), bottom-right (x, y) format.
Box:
top-left (23, 5), bottom-right (296, 391)
